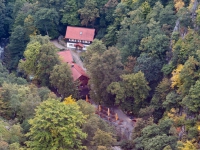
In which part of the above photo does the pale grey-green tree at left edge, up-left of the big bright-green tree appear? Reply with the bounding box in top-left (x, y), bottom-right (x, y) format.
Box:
top-left (1, 83), bottom-right (41, 121)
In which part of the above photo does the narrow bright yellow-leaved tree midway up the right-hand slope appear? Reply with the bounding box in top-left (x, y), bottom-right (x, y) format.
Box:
top-left (171, 64), bottom-right (183, 89)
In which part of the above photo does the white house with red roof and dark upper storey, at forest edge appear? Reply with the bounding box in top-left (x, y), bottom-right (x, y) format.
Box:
top-left (65, 26), bottom-right (95, 50)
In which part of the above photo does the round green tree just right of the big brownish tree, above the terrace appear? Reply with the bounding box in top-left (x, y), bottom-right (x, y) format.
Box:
top-left (107, 72), bottom-right (150, 113)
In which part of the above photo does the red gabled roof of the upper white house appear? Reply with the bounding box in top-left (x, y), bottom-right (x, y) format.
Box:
top-left (65, 26), bottom-right (95, 41)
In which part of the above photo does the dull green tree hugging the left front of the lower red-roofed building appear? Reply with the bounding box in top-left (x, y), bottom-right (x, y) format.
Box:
top-left (49, 63), bottom-right (78, 98)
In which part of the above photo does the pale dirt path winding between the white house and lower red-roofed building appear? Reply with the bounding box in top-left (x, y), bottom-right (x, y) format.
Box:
top-left (51, 40), bottom-right (86, 70)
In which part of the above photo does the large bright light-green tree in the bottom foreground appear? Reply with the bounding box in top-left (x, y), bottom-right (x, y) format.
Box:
top-left (26, 99), bottom-right (87, 150)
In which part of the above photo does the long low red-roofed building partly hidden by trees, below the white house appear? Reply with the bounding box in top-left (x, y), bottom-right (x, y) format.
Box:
top-left (58, 50), bottom-right (89, 86)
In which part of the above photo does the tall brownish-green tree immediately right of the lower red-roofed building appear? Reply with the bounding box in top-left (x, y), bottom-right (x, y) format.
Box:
top-left (86, 47), bottom-right (123, 105)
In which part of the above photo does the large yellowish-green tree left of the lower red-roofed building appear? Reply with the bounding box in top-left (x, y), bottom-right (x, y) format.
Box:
top-left (19, 36), bottom-right (60, 86)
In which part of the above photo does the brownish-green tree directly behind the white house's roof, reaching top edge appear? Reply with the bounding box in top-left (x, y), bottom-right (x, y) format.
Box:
top-left (78, 0), bottom-right (99, 27)
